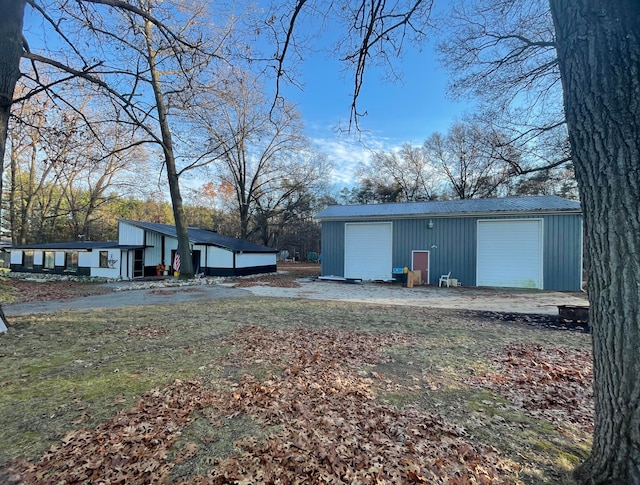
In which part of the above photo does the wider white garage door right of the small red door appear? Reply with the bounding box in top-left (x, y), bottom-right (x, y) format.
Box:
top-left (476, 219), bottom-right (542, 289)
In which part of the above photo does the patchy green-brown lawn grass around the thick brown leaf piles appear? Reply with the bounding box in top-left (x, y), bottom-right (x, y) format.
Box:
top-left (0, 286), bottom-right (590, 484)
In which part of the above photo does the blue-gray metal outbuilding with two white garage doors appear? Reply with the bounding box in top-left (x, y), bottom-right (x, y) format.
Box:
top-left (316, 196), bottom-right (583, 291)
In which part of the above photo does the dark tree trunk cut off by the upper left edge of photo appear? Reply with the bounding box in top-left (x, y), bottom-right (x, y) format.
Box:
top-left (0, 0), bottom-right (25, 332)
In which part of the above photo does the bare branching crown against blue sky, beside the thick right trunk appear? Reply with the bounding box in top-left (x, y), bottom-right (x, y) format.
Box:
top-left (439, 0), bottom-right (570, 173)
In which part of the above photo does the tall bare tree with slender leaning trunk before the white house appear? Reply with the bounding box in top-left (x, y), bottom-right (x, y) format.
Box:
top-left (10, 0), bottom-right (242, 276)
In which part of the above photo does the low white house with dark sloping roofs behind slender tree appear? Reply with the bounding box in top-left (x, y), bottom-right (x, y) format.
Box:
top-left (11, 219), bottom-right (278, 279)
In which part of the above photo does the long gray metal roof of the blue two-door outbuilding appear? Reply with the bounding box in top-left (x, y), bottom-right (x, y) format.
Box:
top-left (316, 195), bottom-right (581, 220)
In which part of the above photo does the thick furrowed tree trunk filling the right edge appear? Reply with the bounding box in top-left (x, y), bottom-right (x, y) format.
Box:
top-left (550, 0), bottom-right (640, 485)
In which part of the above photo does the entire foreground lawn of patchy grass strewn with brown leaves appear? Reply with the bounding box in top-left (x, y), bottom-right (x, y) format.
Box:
top-left (0, 298), bottom-right (593, 484)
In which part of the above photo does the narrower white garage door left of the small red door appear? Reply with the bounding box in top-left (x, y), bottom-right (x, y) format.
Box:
top-left (344, 222), bottom-right (393, 280)
